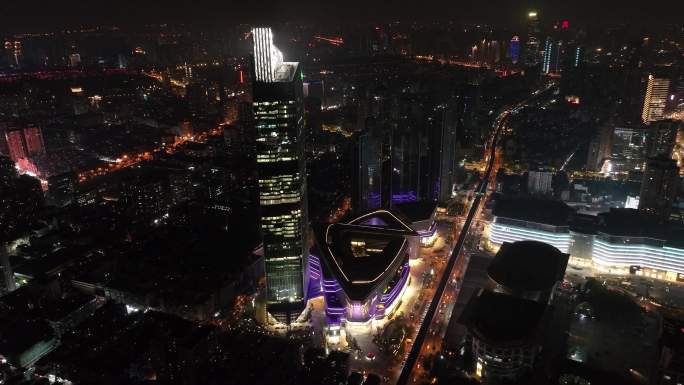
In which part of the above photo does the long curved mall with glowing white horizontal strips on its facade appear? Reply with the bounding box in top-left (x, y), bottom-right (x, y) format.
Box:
top-left (488, 199), bottom-right (684, 282)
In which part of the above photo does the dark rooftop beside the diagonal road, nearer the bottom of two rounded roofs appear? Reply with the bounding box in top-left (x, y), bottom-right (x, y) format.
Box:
top-left (460, 290), bottom-right (546, 345)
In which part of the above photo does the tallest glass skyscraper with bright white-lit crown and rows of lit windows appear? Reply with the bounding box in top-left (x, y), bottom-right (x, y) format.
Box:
top-left (252, 28), bottom-right (308, 316)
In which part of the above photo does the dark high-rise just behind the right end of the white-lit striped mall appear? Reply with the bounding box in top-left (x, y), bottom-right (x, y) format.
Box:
top-left (639, 155), bottom-right (680, 220)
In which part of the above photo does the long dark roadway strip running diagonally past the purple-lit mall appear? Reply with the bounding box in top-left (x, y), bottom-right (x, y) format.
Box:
top-left (397, 85), bottom-right (554, 385)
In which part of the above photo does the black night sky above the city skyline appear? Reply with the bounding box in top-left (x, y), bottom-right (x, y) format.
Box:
top-left (0, 0), bottom-right (684, 31)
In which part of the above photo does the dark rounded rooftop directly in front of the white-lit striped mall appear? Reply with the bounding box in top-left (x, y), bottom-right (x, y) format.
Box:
top-left (488, 241), bottom-right (568, 291)
